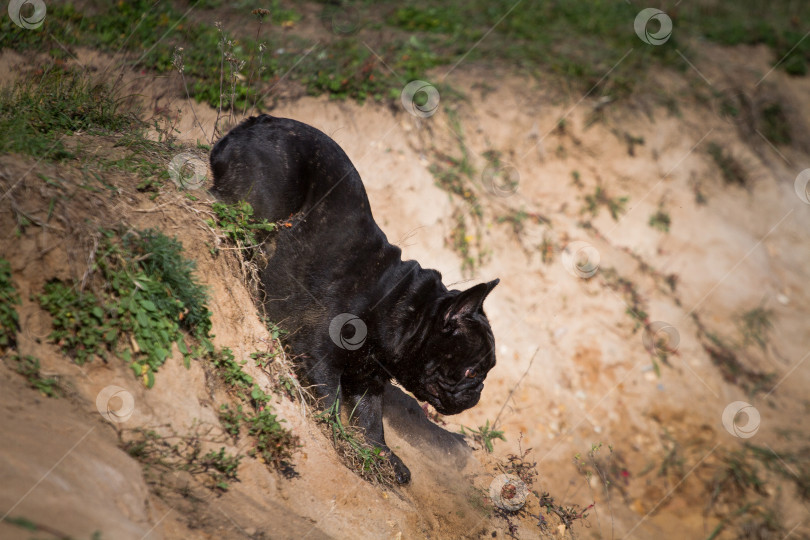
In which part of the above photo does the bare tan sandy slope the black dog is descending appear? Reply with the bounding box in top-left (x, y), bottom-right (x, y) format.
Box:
top-left (0, 35), bottom-right (810, 538)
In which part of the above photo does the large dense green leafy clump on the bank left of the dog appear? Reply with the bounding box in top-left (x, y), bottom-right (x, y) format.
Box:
top-left (37, 229), bottom-right (211, 387)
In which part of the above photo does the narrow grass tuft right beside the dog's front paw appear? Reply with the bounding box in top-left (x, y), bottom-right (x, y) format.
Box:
top-left (316, 399), bottom-right (396, 486)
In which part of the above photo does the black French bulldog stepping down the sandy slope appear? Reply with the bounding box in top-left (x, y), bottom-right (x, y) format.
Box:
top-left (211, 115), bottom-right (499, 483)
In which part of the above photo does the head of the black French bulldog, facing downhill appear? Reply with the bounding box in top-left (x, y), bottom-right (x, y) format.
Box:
top-left (400, 279), bottom-right (499, 414)
